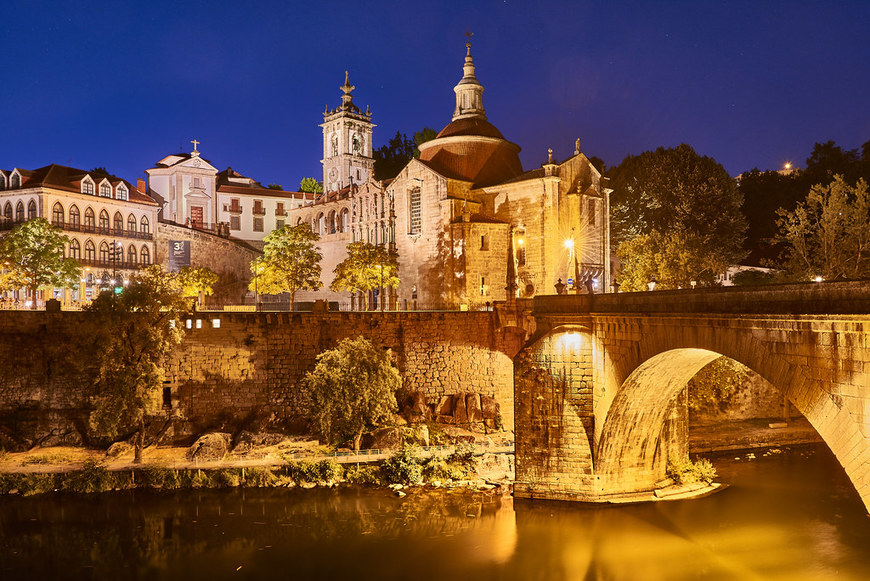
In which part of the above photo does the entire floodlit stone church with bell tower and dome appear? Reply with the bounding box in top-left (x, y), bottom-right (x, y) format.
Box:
top-left (287, 43), bottom-right (610, 309)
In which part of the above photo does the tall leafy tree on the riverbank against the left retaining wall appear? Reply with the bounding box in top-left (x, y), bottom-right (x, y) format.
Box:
top-left (80, 265), bottom-right (186, 463)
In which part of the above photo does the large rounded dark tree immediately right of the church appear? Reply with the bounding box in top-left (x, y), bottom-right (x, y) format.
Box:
top-left (611, 144), bottom-right (746, 290)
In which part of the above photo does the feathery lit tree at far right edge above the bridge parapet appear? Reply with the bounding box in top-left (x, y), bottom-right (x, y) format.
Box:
top-left (777, 175), bottom-right (870, 281)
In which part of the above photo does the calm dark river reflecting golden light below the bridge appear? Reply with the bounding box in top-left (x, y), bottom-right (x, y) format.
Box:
top-left (0, 446), bottom-right (870, 581)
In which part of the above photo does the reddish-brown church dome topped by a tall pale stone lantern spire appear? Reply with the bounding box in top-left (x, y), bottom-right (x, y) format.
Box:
top-left (420, 43), bottom-right (523, 187)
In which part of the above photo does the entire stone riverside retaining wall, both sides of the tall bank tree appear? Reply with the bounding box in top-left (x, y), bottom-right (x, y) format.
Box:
top-left (0, 311), bottom-right (523, 442)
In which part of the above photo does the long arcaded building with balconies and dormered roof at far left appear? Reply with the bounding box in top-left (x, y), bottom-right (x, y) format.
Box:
top-left (0, 164), bottom-right (158, 302)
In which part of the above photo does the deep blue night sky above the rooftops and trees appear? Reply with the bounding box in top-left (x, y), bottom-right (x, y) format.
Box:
top-left (0, 0), bottom-right (870, 189)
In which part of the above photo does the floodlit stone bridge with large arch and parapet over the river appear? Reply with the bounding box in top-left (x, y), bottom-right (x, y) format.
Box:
top-left (514, 282), bottom-right (870, 510)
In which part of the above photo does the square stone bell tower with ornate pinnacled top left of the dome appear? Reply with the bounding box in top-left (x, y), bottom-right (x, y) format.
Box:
top-left (320, 71), bottom-right (375, 193)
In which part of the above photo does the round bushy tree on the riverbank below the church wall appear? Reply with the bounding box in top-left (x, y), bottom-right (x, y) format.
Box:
top-left (302, 337), bottom-right (402, 450)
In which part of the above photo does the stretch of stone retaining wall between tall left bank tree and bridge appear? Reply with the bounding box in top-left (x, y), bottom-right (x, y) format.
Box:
top-left (168, 312), bottom-right (522, 429)
